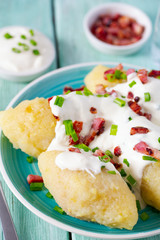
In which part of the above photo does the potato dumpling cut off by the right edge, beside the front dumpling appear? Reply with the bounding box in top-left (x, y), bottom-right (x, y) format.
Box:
top-left (141, 163), bottom-right (160, 210)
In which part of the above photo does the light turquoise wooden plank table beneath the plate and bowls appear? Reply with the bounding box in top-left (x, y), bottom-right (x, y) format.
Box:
top-left (0, 0), bottom-right (160, 240)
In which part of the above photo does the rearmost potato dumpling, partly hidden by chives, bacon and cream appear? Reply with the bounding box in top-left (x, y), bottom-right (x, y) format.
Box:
top-left (84, 65), bottom-right (127, 93)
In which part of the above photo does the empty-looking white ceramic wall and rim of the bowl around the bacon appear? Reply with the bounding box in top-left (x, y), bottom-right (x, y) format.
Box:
top-left (83, 2), bottom-right (152, 55)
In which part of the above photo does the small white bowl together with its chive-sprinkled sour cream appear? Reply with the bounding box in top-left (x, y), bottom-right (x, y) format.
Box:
top-left (0, 26), bottom-right (55, 82)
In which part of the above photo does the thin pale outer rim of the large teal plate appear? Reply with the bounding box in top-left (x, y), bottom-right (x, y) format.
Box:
top-left (0, 61), bottom-right (160, 240)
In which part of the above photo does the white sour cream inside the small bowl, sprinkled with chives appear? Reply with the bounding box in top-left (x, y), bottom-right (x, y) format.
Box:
top-left (0, 26), bottom-right (53, 73)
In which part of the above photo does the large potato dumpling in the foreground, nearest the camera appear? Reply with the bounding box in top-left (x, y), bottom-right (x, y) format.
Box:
top-left (38, 151), bottom-right (138, 230)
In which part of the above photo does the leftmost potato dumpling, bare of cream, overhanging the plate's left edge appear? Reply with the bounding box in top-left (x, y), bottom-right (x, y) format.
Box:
top-left (0, 98), bottom-right (56, 157)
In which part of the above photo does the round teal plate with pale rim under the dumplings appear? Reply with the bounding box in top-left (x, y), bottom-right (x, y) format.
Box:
top-left (0, 63), bottom-right (160, 239)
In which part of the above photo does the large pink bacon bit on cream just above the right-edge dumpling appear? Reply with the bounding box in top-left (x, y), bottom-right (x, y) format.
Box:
top-left (133, 141), bottom-right (160, 160)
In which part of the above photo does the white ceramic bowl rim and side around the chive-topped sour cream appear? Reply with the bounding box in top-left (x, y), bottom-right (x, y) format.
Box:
top-left (0, 26), bottom-right (56, 82)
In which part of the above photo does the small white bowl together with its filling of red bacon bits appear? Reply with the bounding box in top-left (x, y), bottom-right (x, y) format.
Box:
top-left (84, 3), bottom-right (152, 55)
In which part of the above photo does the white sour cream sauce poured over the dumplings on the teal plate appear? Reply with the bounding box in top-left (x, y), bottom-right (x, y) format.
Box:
top-left (48, 73), bottom-right (160, 206)
